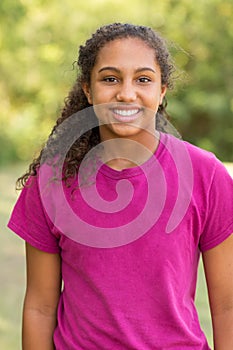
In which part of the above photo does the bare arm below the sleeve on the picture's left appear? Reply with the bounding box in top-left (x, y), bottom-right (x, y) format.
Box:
top-left (23, 243), bottom-right (61, 350)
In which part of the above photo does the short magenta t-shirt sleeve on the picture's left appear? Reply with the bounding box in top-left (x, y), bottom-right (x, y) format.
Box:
top-left (8, 176), bottom-right (60, 253)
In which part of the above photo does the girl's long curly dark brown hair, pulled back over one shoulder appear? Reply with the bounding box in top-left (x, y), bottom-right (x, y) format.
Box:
top-left (17, 23), bottom-right (175, 189)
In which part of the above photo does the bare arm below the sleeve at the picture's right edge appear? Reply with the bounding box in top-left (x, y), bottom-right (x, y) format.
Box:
top-left (203, 234), bottom-right (233, 350)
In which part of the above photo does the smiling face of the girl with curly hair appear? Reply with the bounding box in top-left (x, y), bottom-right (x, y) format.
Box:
top-left (83, 38), bottom-right (166, 141)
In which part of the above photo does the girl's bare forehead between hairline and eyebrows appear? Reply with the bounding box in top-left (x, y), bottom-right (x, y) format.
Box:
top-left (95, 37), bottom-right (157, 66)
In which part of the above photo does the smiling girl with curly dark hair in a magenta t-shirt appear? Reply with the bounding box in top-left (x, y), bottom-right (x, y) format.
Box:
top-left (9, 23), bottom-right (233, 350)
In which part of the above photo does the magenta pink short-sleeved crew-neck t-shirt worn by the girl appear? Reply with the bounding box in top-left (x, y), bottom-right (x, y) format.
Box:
top-left (9, 133), bottom-right (233, 350)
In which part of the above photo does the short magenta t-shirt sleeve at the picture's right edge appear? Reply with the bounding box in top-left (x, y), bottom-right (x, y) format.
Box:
top-left (199, 158), bottom-right (233, 251)
